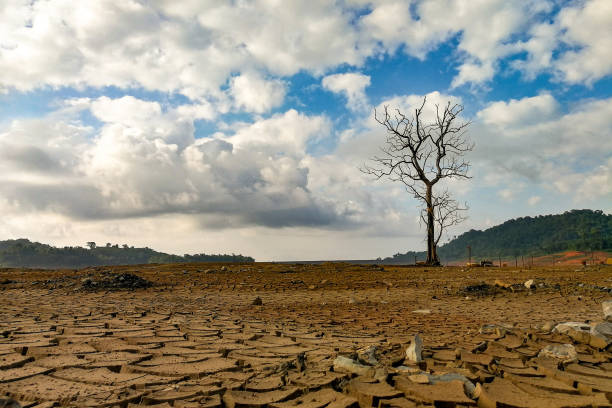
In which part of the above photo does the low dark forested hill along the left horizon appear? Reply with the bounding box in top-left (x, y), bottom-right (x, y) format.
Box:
top-left (0, 239), bottom-right (255, 268)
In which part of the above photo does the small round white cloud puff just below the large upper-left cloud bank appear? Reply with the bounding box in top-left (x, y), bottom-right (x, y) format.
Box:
top-left (230, 73), bottom-right (286, 113)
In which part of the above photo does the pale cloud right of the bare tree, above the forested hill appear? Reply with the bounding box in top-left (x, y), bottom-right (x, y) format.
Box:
top-left (472, 94), bottom-right (612, 203)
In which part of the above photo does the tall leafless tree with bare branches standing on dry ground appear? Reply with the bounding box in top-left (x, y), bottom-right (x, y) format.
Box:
top-left (361, 97), bottom-right (474, 265)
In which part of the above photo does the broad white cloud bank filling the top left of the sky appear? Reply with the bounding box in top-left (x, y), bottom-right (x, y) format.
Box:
top-left (0, 0), bottom-right (365, 97)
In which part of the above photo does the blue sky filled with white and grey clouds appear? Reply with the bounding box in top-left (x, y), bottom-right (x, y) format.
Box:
top-left (0, 0), bottom-right (612, 261)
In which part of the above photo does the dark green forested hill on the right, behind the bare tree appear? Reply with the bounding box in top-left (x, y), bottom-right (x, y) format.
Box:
top-left (383, 210), bottom-right (612, 263)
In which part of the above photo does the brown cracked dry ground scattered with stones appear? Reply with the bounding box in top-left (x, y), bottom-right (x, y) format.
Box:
top-left (0, 263), bottom-right (612, 408)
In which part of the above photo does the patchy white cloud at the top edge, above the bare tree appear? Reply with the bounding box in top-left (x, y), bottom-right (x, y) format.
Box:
top-left (361, 0), bottom-right (551, 87)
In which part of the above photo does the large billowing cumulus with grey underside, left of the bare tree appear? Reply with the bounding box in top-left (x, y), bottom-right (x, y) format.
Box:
top-left (0, 96), bottom-right (350, 228)
